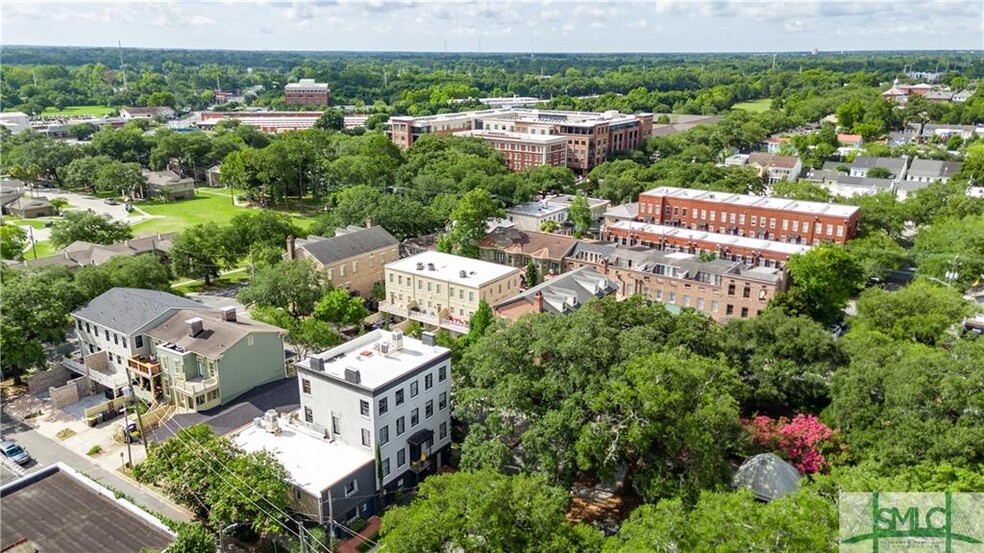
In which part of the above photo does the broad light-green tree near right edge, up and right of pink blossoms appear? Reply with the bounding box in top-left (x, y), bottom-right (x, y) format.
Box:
top-left (854, 279), bottom-right (973, 345)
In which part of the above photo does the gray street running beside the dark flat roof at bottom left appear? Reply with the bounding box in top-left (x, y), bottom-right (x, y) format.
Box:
top-left (0, 404), bottom-right (191, 522)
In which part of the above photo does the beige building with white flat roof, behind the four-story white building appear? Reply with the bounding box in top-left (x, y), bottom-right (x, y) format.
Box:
top-left (379, 252), bottom-right (523, 333)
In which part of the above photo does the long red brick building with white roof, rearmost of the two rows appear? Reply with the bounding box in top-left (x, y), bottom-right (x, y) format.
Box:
top-left (638, 186), bottom-right (861, 244)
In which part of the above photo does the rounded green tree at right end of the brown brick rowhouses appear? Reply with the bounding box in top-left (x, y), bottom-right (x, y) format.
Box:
top-left (772, 243), bottom-right (864, 324)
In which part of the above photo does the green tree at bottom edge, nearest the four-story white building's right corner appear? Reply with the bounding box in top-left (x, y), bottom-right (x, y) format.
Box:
top-left (380, 471), bottom-right (602, 553)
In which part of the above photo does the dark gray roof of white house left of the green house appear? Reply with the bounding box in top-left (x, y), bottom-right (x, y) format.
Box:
top-left (72, 288), bottom-right (206, 334)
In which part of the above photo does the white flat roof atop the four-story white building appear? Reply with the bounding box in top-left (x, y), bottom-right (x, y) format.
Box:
top-left (297, 329), bottom-right (451, 390)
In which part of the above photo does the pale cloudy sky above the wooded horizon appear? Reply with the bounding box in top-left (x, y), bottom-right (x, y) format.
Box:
top-left (0, 0), bottom-right (984, 53)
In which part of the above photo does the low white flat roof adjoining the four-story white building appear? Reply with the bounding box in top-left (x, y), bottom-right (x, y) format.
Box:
top-left (232, 417), bottom-right (375, 497)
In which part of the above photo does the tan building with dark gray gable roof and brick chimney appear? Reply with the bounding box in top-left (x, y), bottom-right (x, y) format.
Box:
top-left (287, 226), bottom-right (400, 298)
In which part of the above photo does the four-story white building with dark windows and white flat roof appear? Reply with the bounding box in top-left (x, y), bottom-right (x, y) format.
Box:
top-left (297, 330), bottom-right (451, 502)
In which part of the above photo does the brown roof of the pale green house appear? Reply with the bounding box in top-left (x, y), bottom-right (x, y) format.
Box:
top-left (147, 309), bottom-right (286, 359)
